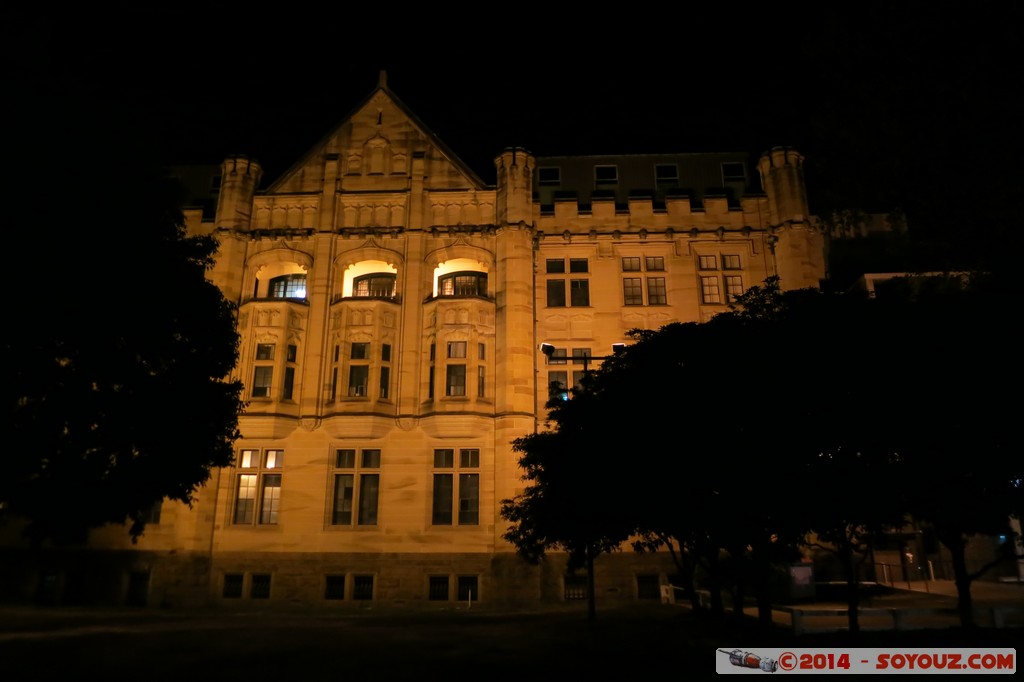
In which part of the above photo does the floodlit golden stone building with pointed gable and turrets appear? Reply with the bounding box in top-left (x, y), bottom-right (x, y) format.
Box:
top-left (2, 77), bottom-right (825, 607)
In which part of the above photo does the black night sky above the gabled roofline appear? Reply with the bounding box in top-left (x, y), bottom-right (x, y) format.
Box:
top-left (4, 0), bottom-right (1022, 212)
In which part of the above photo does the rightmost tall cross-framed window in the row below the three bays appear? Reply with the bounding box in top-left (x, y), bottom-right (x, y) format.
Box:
top-left (431, 449), bottom-right (480, 525)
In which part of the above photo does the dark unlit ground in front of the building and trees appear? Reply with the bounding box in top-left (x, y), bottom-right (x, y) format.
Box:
top-left (0, 604), bottom-right (1024, 682)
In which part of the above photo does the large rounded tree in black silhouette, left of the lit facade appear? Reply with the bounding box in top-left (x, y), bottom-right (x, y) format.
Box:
top-left (0, 93), bottom-right (243, 542)
